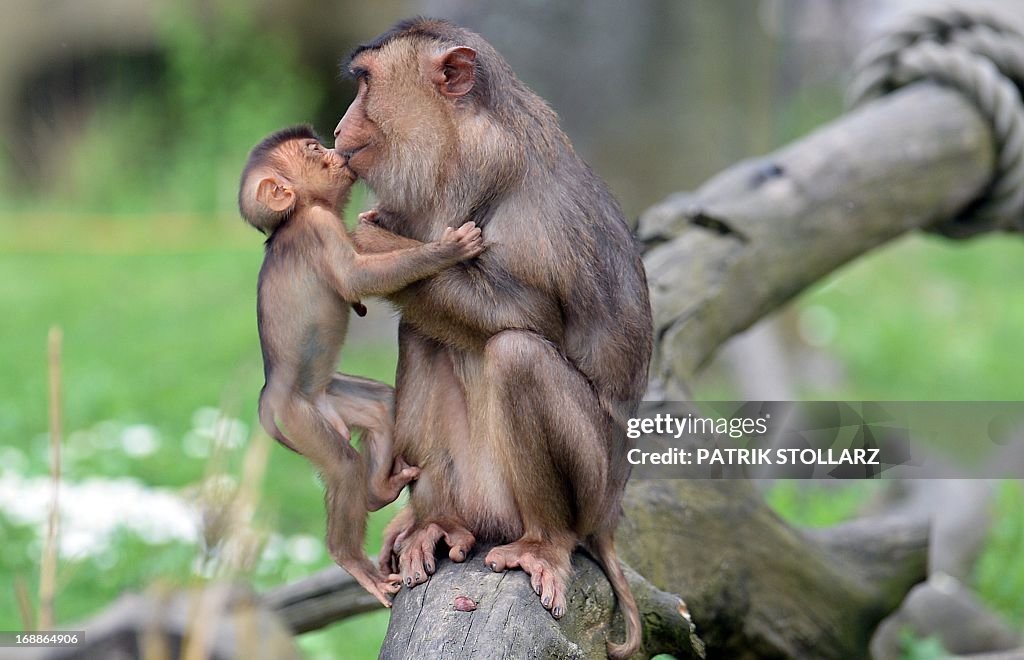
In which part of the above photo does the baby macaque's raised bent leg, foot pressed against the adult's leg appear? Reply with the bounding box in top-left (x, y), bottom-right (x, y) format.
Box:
top-left (326, 373), bottom-right (420, 511)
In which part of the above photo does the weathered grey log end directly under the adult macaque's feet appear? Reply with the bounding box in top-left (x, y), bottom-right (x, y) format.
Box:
top-left (380, 547), bottom-right (703, 659)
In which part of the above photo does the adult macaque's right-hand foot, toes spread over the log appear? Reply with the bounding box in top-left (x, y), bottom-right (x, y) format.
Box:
top-left (483, 538), bottom-right (574, 619)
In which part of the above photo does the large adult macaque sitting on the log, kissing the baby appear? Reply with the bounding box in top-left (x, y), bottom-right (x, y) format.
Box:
top-left (335, 19), bottom-right (651, 658)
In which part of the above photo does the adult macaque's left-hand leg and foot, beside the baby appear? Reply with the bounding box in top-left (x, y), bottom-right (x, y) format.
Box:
top-left (385, 323), bottom-right (476, 586)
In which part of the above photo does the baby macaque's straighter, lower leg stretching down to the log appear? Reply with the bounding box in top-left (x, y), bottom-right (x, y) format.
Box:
top-left (280, 396), bottom-right (399, 607)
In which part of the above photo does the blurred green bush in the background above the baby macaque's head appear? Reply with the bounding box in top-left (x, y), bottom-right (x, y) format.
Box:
top-left (53, 0), bottom-right (323, 213)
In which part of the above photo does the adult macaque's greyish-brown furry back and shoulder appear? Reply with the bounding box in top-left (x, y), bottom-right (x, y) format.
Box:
top-left (484, 150), bottom-right (653, 410)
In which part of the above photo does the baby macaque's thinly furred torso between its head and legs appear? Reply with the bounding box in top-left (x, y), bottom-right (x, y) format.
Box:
top-left (256, 214), bottom-right (349, 394)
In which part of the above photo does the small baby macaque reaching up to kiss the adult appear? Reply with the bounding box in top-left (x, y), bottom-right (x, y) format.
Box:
top-left (239, 126), bottom-right (483, 607)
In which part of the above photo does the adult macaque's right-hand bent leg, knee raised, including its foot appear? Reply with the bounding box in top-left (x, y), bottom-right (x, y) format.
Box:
top-left (475, 331), bottom-right (612, 618)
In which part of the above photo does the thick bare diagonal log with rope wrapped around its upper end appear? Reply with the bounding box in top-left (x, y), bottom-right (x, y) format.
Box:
top-left (639, 83), bottom-right (993, 387)
